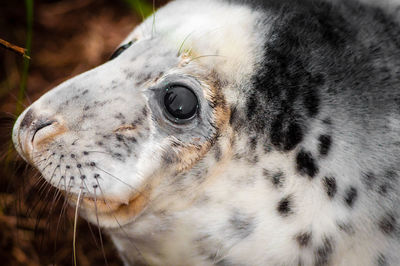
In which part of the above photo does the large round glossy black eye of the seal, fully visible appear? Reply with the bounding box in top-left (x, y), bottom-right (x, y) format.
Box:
top-left (164, 85), bottom-right (199, 122)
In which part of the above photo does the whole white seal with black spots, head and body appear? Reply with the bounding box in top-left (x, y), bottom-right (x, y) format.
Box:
top-left (13, 0), bottom-right (400, 265)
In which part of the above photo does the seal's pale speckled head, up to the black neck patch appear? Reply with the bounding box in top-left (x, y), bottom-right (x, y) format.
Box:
top-left (13, 1), bottom-right (264, 226)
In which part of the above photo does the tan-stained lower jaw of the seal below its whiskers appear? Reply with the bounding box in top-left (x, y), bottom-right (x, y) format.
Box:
top-left (66, 189), bottom-right (150, 227)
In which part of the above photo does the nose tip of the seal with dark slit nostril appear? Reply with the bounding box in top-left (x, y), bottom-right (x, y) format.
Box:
top-left (13, 108), bottom-right (65, 159)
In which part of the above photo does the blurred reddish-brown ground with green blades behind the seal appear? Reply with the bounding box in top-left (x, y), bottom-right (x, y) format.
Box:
top-left (0, 0), bottom-right (167, 265)
